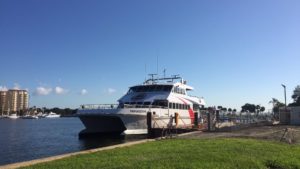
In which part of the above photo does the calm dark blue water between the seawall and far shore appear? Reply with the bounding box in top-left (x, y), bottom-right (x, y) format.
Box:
top-left (0, 118), bottom-right (143, 165)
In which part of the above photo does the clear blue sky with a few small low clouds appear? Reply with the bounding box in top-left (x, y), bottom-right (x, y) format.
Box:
top-left (0, 0), bottom-right (300, 109)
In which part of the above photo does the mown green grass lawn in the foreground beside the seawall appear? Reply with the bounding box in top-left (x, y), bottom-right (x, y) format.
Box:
top-left (22, 139), bottom-right (300, 169)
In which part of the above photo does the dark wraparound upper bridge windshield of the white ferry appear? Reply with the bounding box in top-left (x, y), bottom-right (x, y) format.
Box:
top-left (128, 85), bottom-right (173, 93)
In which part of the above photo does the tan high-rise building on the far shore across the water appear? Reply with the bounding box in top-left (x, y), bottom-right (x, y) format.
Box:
top-left (0, 89), bottom-right (29, 115)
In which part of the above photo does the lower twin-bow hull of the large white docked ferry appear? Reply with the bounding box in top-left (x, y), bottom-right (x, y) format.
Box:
top-left (77, 108), bottom-right (195, 135)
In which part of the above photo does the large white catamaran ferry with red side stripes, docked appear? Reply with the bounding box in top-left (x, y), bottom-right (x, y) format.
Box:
top-left (77, 75), bottom-right (205, 135)
